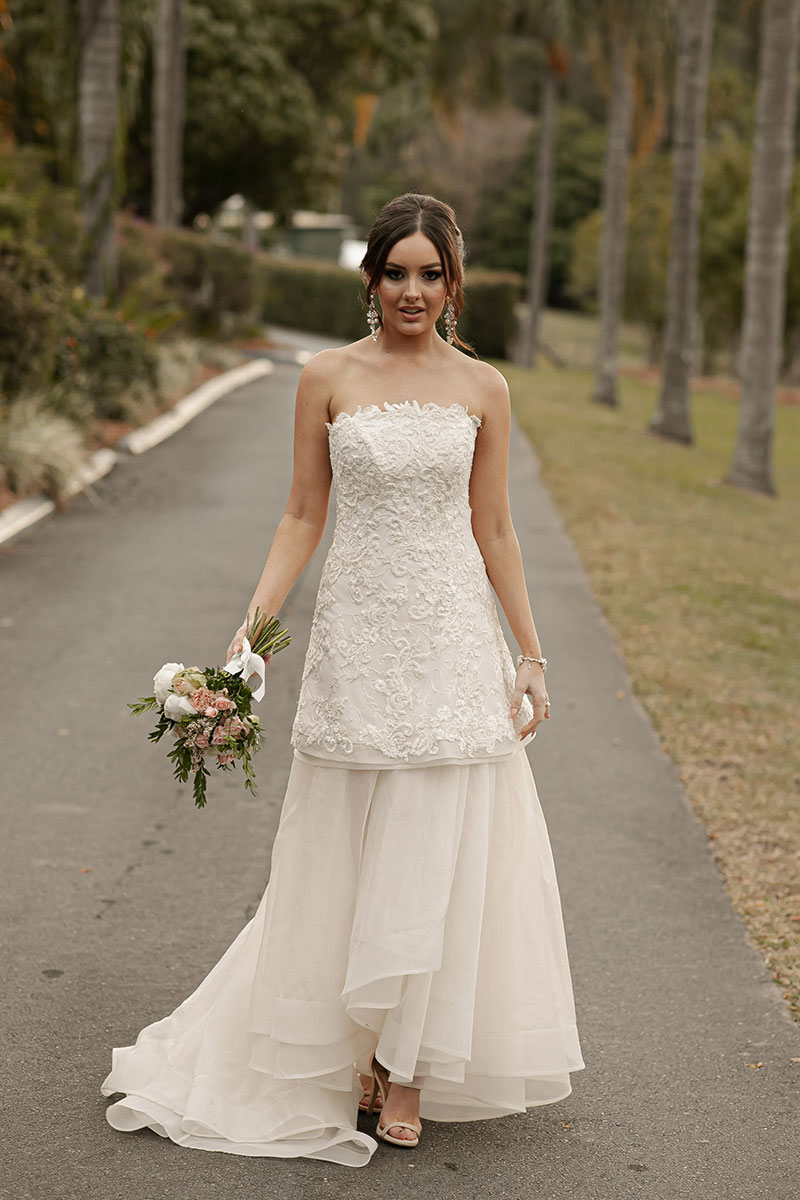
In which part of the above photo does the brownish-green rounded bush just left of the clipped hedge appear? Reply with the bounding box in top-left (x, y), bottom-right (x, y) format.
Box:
top-left (160, 230), bottom-right (259, 334)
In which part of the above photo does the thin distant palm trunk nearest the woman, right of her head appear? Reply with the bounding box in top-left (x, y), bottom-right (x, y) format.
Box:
top-left (519, 64), bottom-right (558, 367)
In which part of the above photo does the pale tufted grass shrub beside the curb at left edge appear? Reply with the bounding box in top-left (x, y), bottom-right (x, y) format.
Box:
top-left (0, 396), bottom-right (85, 502)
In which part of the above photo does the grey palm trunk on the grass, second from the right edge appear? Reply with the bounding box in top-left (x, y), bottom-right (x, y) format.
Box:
top-left (650, 0), bottom-right (716, 444)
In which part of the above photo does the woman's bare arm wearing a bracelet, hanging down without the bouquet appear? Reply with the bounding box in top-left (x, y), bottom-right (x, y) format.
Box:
top-left (469, 364), bottom-right (549, 737)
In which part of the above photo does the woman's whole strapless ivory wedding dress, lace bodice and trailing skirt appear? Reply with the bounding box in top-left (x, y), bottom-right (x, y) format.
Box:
top-left (102, 402), bottom-right (583, 1166)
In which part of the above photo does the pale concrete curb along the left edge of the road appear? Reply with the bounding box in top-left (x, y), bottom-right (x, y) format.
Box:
top-left (0, 359), bottom-right (275, 546)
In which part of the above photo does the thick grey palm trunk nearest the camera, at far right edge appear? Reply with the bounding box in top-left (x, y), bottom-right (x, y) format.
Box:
top-left (726, 0), bottom-right (800, 494)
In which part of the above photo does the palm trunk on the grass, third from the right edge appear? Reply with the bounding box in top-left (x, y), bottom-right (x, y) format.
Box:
top-left (593, 25), bottom-right (633, 407)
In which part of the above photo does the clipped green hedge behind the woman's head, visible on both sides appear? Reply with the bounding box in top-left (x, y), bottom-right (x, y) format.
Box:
top-left (258, 256), bottom-right (522, 359)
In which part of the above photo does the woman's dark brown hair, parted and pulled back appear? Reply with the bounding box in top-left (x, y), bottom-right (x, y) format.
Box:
top-left (361, 192), bottom-right (475, 354)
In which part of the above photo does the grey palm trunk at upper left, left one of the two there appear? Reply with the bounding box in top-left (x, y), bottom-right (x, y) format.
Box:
top-left (78, 0), bottom-right (120, 300)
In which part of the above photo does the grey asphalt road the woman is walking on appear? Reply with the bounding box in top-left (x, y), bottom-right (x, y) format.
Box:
top-left (0, 350), bottom-right (800, 1200)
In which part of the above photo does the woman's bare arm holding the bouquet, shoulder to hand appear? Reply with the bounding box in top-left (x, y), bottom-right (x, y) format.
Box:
top-left (227, 350), bottom-right (335, 661)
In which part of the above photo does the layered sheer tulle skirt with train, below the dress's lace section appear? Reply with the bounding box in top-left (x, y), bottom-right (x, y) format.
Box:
top-left (102, 750), bottom-right (583, 1166)
